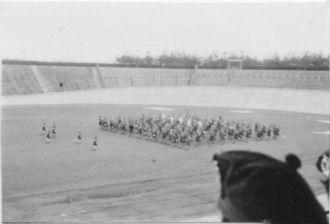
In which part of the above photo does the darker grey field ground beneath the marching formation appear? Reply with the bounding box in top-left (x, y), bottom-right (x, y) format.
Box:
top-left (1, 104), bottom-right (329, 223)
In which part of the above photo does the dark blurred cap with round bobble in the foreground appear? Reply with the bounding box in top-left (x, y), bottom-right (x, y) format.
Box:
top-left (213, 151), bottom-right (328, 224)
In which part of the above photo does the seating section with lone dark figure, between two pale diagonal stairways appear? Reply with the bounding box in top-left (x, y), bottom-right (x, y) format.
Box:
top-left (38, 66), bottom-right (96, 92)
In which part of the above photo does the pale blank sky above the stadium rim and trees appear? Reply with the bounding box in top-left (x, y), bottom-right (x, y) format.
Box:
top-left (1, 2), bottom-right (330, 63)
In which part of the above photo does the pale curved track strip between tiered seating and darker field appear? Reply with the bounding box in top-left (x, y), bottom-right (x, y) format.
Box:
top-left (2, 86), bottom-right (330, 115)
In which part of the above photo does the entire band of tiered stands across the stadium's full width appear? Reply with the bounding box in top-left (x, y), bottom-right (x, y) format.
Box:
top-left (1, 64), bottom-right (330, 95)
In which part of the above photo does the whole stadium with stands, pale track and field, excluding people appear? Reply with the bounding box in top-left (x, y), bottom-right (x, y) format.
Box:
top-left (1, 61), bottom-right (329, 223)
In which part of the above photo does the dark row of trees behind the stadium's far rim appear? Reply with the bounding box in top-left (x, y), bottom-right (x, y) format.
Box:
top-left (116, 52), bottom-right (329, 70)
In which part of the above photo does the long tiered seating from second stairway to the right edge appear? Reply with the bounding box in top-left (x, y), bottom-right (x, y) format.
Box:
top-left (96, 67), bottom-right (329, 89)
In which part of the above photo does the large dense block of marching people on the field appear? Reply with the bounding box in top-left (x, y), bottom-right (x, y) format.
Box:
top-left (99, 113), bottom-right (280, 146)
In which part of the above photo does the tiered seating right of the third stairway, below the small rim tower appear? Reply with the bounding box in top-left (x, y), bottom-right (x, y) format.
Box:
top-left (193, 70), bottom-right (329, 89)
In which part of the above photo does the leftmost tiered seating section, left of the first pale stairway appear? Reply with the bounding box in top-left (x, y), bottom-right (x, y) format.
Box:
top-left (2, 65), bottom-right (43, 95)
